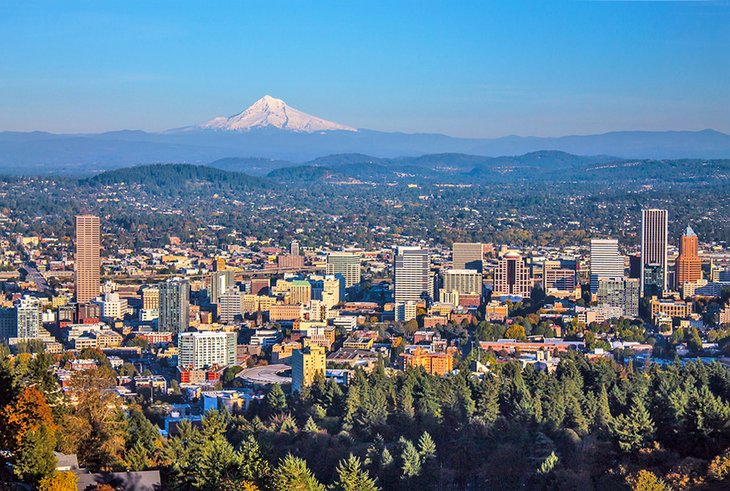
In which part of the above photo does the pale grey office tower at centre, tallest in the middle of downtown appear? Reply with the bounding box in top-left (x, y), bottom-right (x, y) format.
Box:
top-left (393, 246), bottom-right (432, 303)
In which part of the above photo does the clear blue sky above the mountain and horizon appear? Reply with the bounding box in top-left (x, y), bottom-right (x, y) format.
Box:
top-left (0, 0), bottom-right (730, 137)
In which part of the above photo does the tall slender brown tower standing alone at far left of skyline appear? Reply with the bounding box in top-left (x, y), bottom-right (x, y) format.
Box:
top-left (75, 215), bottom-right (101, 303)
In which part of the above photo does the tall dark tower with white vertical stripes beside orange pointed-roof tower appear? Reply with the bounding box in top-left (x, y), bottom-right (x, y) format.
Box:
top-left (641, 209), bottom-right (669, 297)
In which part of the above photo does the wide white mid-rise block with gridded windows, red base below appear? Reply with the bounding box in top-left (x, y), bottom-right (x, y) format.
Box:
top-left (177, 331), bottom-right (237, 370)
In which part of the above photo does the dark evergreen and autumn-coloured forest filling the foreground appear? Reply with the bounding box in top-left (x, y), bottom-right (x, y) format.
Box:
top-left (0, 353), bottom-right (730, 491)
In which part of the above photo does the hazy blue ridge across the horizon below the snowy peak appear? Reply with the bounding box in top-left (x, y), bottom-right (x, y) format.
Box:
top-left (0, 125), bottom-right (730, 175)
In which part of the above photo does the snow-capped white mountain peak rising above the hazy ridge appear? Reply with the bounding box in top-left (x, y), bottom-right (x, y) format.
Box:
top-left (198, 95), bottom-right (357, 133)
